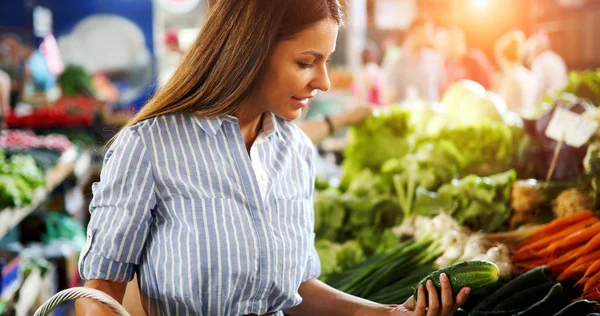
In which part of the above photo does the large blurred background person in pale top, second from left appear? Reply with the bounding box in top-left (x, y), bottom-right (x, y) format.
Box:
top-left (382, 20), bottom-right (445, 104)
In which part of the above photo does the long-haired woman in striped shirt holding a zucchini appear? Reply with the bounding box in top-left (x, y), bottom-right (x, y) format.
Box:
top-left (77, 0), bottom-right (468, 315)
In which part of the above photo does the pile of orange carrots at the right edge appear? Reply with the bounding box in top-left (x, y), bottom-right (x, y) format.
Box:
top-left (511, 211), bottom-right (600, 301)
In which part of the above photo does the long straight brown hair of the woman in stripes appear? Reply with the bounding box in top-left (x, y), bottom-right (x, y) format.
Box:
top-left (126, 0), bottom-right (342, 126)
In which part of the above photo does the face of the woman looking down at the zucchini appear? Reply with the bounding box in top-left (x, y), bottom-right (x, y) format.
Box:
top-left (255, 19), bottom-right (338, 120)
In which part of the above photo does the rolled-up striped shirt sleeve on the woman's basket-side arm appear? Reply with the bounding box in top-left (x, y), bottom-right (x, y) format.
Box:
top-left (79, 127), bottom-right (156, 282)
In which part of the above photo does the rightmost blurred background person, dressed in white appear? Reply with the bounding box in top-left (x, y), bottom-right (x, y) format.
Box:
top-left (526, 30), bottom-right (568, 101)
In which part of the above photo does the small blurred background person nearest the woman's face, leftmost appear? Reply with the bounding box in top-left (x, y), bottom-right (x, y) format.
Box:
top-left (352, 42), bottom-right (383, 105)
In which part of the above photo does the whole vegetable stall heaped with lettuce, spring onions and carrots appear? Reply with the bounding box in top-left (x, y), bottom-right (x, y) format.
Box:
top-left (315, 71), bottom-right (600, 315)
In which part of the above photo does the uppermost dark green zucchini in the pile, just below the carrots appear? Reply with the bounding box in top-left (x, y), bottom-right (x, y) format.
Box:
top-left (473, 266), bottom-right (550, 311)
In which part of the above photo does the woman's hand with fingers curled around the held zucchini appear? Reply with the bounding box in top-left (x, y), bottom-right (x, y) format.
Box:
top-left (390, 273), bottom-right (471, 316)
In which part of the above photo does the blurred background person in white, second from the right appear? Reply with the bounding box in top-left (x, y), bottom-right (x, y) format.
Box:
top-left (494, 31), bottom-right (538, 116)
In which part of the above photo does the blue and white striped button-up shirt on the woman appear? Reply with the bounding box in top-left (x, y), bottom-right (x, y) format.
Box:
top-left (79, 114), bottom-right (320, 315)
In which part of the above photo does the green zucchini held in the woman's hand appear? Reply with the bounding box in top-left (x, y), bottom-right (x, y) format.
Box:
top-left (414, 260), bottom-right (500, 302)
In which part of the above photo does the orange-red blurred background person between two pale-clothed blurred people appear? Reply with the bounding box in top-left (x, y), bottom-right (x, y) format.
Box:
top-left (435, 26), bottom-right (493, 91)
